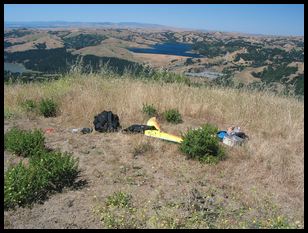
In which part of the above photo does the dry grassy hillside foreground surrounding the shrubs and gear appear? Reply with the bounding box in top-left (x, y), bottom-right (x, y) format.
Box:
top-left (4, 73), bottom-right (304, 228)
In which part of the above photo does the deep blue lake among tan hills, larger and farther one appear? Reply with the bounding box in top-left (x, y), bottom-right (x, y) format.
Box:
top-left (128, 43), bottom-right (204, 58)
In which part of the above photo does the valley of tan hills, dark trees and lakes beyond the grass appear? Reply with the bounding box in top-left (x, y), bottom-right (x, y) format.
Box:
top-left (4, 25), bottom-right (304, 94)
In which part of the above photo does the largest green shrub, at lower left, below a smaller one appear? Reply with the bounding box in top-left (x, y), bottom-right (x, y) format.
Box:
top-left (4, 150), bottom-right (78, 209)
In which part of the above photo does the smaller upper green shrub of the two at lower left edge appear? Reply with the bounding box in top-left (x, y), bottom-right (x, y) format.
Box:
top-left (4, 127), bottom-right (45, 157)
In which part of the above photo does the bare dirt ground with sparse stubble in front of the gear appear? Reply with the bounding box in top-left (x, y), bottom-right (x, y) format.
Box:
top-left (4, 114), bottom-right (304, 229)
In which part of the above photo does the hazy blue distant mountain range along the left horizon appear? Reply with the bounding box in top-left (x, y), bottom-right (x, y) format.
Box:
top-left (4, 21), bottom-right (176, 29)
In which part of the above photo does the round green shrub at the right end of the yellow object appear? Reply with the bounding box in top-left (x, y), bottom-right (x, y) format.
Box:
top-left (180, 124), bottom-right (225, 163)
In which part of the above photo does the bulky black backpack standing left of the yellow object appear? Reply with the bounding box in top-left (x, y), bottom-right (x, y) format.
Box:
top-left (93, 111), bottom-right (121, 133)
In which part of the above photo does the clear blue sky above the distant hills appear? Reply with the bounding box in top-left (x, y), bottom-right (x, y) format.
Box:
top-left (4, 4), bottom-right (304, 36)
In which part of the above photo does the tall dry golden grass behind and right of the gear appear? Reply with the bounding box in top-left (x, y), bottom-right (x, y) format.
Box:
top-left (4, 74), bottom-right (304, 226)
